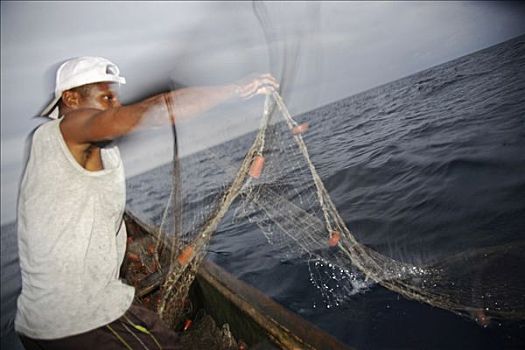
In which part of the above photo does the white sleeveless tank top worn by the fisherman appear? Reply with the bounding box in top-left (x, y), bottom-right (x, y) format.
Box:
top-left (15, 119), bottom-right (135, 339)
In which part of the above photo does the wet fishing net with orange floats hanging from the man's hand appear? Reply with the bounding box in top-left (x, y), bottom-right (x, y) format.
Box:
top-left (154, 92), bottom-right (525, 323)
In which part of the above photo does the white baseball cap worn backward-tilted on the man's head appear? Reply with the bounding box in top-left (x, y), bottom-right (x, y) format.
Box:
top-left (40, 56), bottom-right (126, 119)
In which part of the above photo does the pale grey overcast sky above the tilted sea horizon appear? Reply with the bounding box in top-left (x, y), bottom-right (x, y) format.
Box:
top-left (1, 1), bottom-right (525, 224)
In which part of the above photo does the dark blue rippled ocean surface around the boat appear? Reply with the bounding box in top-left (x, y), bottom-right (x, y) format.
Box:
top-left (2, 36), bottom-right (525, 349)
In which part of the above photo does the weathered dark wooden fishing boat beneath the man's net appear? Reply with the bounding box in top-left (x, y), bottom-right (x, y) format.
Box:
top-left (122, 212), bottom-right (349, 350)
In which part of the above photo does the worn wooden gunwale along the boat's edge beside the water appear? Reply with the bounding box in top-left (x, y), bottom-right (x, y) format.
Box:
top-left (125, 210), bottom-right (351, 350)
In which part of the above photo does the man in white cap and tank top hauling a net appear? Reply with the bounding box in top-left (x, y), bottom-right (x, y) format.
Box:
top-left (15, 57), bottom-right (277, 349)
